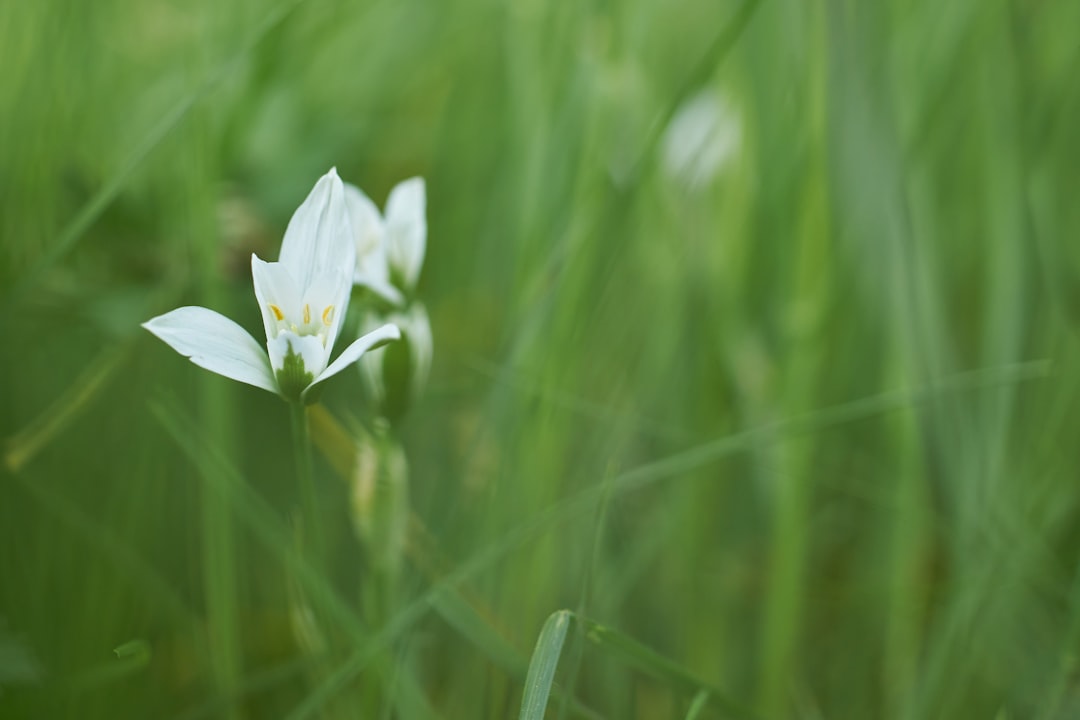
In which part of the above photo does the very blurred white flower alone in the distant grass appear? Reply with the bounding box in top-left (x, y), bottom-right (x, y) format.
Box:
top-left (663, 90), bottom-right (742, 190)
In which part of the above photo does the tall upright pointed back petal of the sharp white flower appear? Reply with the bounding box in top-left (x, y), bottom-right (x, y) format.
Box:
top-left (280, 169), bottom-right (356, 294)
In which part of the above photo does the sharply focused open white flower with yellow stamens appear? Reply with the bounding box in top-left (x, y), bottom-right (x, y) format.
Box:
top-left (143, 169), bottom-right (401, 402)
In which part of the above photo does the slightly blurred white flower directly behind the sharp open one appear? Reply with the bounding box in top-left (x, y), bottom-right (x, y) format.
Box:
top-left (345, 177), bottom-right (428, 305)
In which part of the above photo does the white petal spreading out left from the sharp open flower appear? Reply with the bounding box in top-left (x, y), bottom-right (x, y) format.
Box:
top-left (143, 307), bottom-right (278, 393)
